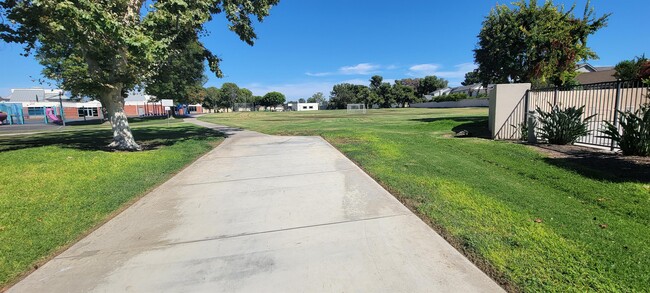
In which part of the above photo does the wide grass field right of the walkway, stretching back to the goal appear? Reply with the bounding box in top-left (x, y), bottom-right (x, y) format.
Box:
top-left (200, 109), bottom-right (650, 292)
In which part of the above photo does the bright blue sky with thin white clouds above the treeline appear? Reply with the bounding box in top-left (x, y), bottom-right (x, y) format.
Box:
top-left (0, 0), bottom-right (650, 99)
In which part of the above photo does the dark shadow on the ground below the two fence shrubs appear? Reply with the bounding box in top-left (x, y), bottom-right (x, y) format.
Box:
top-left (544, 152), bottom-right (650, 183)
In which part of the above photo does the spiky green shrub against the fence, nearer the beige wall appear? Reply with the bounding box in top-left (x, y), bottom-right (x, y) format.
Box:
top-left (537, 104), bottom-right (596, 145)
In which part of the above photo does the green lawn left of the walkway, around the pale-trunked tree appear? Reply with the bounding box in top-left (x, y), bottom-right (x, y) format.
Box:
top-left (0, 121), bottom-right (222, 291)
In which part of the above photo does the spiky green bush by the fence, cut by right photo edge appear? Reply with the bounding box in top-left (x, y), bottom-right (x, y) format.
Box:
top-left (603, 104), bottom-right (650, 157)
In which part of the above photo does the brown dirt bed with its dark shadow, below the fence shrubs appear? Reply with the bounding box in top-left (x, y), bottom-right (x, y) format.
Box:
top-left (529, 145), bottom-right (650, 183)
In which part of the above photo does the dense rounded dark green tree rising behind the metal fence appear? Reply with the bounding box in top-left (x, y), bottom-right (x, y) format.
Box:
top-left (474, 0), bottom-right (609, 85)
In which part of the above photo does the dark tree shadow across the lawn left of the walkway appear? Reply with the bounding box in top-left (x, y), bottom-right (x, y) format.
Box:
top-left (0, 126), bottom-right (224, 151)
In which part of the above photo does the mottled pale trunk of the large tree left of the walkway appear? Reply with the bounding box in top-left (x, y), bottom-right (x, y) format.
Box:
top-left (100, 86), bottom-right (141, 151)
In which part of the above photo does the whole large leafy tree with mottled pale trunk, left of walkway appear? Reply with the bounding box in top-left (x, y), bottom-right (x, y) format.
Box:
top-left (0, 0), bottom-right (279, 150)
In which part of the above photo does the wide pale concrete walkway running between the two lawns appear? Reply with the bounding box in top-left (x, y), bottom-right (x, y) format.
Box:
top-left (10, 119), bottom-right (501, 292)
